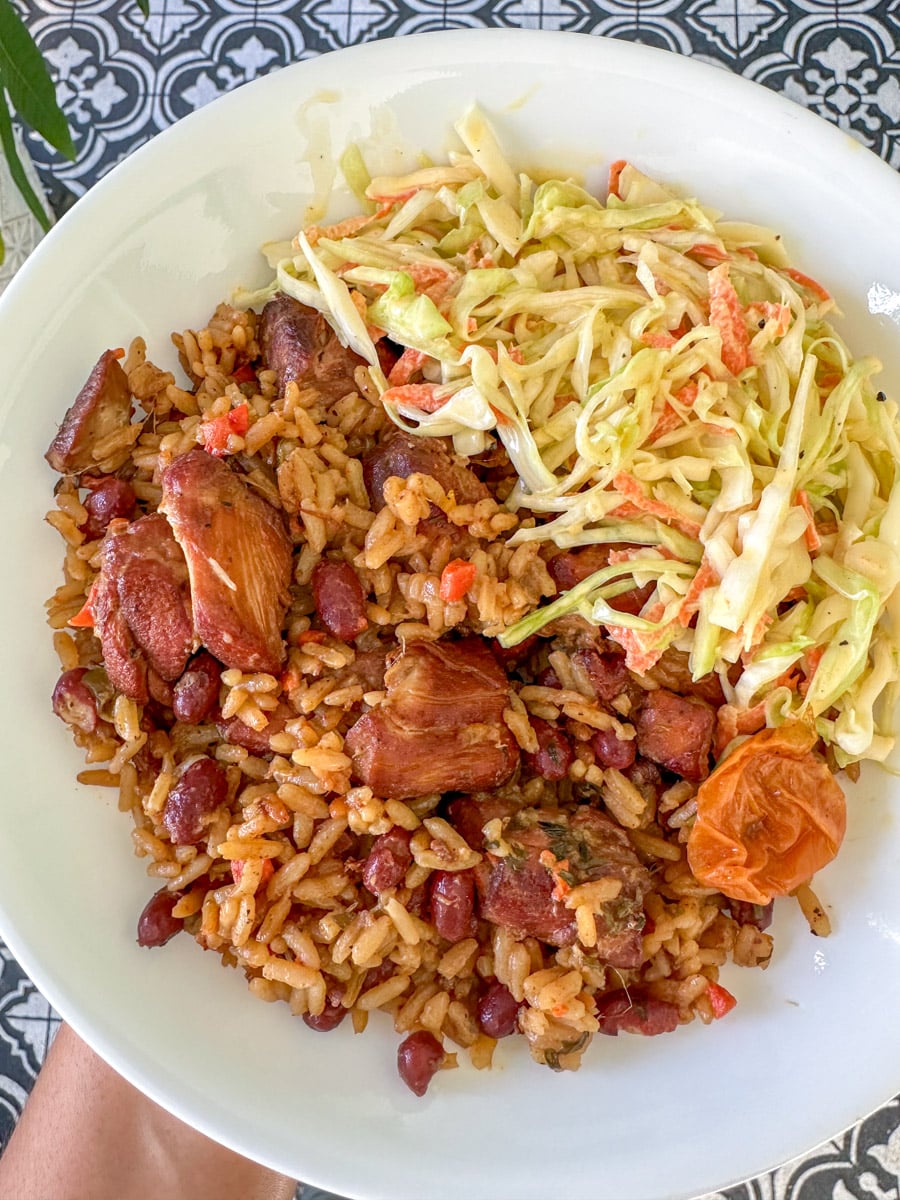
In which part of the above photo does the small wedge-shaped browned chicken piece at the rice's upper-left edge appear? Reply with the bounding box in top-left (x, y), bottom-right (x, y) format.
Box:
top-left (44, 350), bottom-right (133, 475)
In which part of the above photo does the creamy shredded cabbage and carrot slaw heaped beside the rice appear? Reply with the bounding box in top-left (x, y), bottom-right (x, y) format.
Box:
top-left (245, 109), bottom-right (900, 764)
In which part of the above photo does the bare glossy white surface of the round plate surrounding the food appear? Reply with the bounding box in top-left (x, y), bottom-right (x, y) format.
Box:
top-left (0, 31), bottom-right (900, 1200)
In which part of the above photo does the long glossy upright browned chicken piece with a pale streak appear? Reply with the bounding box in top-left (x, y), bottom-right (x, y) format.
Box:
top-left (160, 446), bottom-right (292, 672)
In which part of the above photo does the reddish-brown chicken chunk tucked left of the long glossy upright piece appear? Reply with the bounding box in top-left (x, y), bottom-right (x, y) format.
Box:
top-left (90, 512), bottom-right (193, 704)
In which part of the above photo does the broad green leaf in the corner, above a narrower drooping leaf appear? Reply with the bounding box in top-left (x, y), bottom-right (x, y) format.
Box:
top-left (0, 0), bottom-right (76, 160)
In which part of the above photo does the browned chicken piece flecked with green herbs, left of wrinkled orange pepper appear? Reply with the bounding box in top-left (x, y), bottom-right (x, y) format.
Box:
top-left (475, 806), bottom-right (650, 970)
